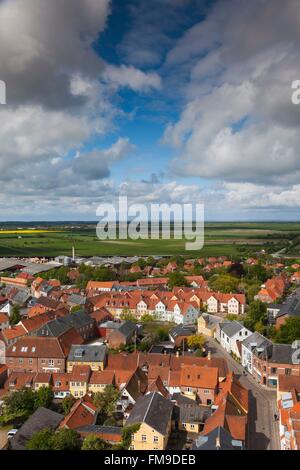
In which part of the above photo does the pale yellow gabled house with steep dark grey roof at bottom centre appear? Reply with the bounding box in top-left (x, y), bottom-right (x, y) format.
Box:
top-left (126, 392), bottom-right (174, 450)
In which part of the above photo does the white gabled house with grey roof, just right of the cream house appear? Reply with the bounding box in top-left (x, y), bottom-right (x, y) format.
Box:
top-left (216, 321), bottom-right (251, 357)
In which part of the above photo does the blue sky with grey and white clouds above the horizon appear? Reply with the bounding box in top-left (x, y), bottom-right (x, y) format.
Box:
top-left (0, 0), bottom-right (300, 221)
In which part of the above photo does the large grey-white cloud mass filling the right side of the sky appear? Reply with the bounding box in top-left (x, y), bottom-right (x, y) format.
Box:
top-left (164, 0), bottom-right (300, 189)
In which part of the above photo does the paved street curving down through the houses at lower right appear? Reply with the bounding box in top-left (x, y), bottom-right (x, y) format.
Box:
top-left (208, 339), bottom-right (280, 450)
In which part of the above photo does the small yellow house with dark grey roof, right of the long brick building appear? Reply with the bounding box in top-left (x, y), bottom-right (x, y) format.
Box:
top-left (67, 344), bottom-right (107, 372)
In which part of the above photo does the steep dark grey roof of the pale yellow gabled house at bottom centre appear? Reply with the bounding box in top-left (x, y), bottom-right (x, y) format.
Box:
top-left (126, 392), bottom-right (174, 435)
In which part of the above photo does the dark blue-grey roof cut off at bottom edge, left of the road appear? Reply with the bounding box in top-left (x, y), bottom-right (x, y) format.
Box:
top-left (191, 426), bottom-right (243, 450)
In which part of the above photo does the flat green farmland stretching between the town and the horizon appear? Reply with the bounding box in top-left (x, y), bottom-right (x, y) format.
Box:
top-left (0, 222), bottom-right (300, 257)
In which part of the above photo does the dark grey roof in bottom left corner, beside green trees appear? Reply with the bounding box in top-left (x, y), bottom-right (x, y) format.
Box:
top-left (10, 407), bottom-right (64, 450)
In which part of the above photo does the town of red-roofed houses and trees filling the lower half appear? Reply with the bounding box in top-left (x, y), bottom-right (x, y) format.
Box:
top-left (0, 250), bottom-right (300, 452)
